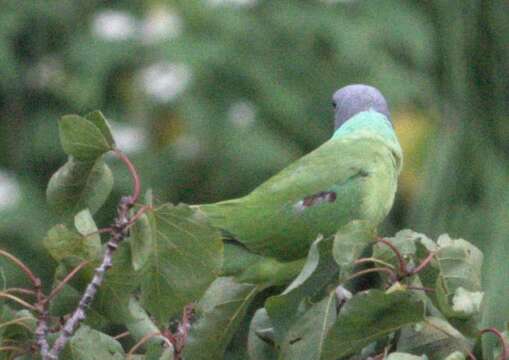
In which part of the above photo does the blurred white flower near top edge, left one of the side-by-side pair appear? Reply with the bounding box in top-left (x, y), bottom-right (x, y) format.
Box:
top-left (92, 10), bottom-right (137, 41)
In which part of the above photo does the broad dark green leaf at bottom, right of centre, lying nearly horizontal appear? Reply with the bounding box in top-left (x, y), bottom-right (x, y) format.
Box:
top-left (321, 290), bottom-right (424, 360)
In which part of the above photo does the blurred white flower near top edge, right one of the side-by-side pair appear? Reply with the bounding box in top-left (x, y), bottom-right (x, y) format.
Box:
top-left (140, 8), bottom-right (183, 43)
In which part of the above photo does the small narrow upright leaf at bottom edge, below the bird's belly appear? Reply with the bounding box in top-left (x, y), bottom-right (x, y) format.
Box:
top-left (247, 308), bottom-right (277, 360)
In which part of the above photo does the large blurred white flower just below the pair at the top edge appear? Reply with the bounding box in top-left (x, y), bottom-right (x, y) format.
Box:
top-left (140, 62), bottom-right (191, 103)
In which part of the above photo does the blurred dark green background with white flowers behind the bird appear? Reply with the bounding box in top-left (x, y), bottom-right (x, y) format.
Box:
top-left (0, 0), bottom-right (509, 354)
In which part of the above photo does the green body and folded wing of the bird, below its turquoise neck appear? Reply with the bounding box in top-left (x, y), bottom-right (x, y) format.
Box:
top-left (200, 133), bottom-right (401, 261)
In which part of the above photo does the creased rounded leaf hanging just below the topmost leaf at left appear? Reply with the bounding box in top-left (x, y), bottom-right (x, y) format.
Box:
top-left (46, 157), bottom-right (113, 216)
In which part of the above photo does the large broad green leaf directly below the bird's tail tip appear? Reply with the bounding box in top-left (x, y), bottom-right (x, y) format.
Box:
top-left (141, 204), bottom-right (223, 321)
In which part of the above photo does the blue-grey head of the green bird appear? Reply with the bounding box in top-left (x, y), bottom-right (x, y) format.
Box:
top-left (332, 84), bottom-right (392, 130)
